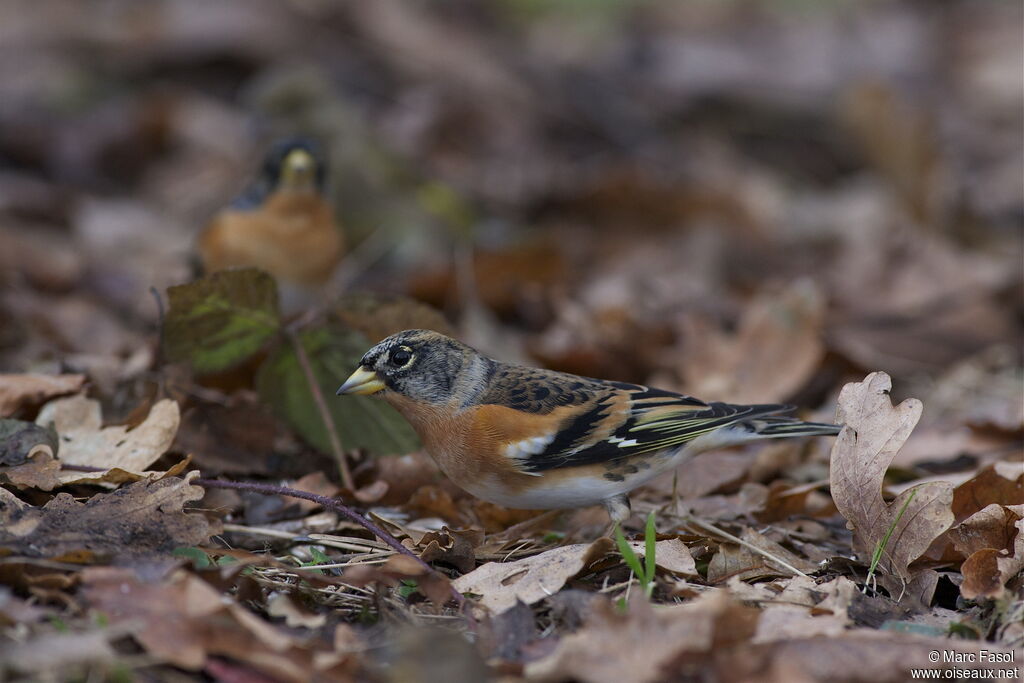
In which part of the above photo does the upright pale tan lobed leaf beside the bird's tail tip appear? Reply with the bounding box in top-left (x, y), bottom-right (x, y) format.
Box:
top-left (830, 373), bottom-right (953, 598)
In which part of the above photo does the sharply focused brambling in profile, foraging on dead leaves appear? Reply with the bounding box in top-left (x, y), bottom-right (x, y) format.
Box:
top-left (338, 330), bottom-right (840, 522)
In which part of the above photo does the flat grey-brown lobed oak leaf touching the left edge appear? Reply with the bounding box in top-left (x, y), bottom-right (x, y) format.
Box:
top-left (0, 472), bottom-right (216, 561)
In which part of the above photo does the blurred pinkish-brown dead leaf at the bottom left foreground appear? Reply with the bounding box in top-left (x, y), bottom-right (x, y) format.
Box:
top-left (82, 567), bottom-right (348, 682)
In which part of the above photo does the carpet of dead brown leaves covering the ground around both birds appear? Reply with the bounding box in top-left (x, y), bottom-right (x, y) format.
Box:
top-left (0, 0), bottom-right (1024, 683)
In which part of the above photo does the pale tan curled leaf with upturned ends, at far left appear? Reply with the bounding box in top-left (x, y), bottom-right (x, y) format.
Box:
top-left (36, 394), bottom-right (180, 483)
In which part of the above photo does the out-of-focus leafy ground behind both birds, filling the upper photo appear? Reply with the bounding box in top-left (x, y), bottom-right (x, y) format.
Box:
top-left (0, 0), bottom-right (1024, 436)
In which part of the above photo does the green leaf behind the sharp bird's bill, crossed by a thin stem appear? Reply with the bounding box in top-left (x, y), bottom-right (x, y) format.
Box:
top-left (256, 323), bottom-right (420, 456)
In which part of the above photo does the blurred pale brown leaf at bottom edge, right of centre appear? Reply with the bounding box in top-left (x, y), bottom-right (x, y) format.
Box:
top-left (524, 591), bottom-right (758, 683)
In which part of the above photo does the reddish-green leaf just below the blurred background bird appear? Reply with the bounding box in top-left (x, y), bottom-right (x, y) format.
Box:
top-left (164, 268), bottom-right (281, 375)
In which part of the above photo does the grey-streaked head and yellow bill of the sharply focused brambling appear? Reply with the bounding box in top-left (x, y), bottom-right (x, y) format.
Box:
top-left (338, 330), bottom-right (477, 404)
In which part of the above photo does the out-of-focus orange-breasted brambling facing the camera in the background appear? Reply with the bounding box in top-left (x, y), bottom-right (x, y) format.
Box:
top-left (199, 139), bottom-right (344, 290)
